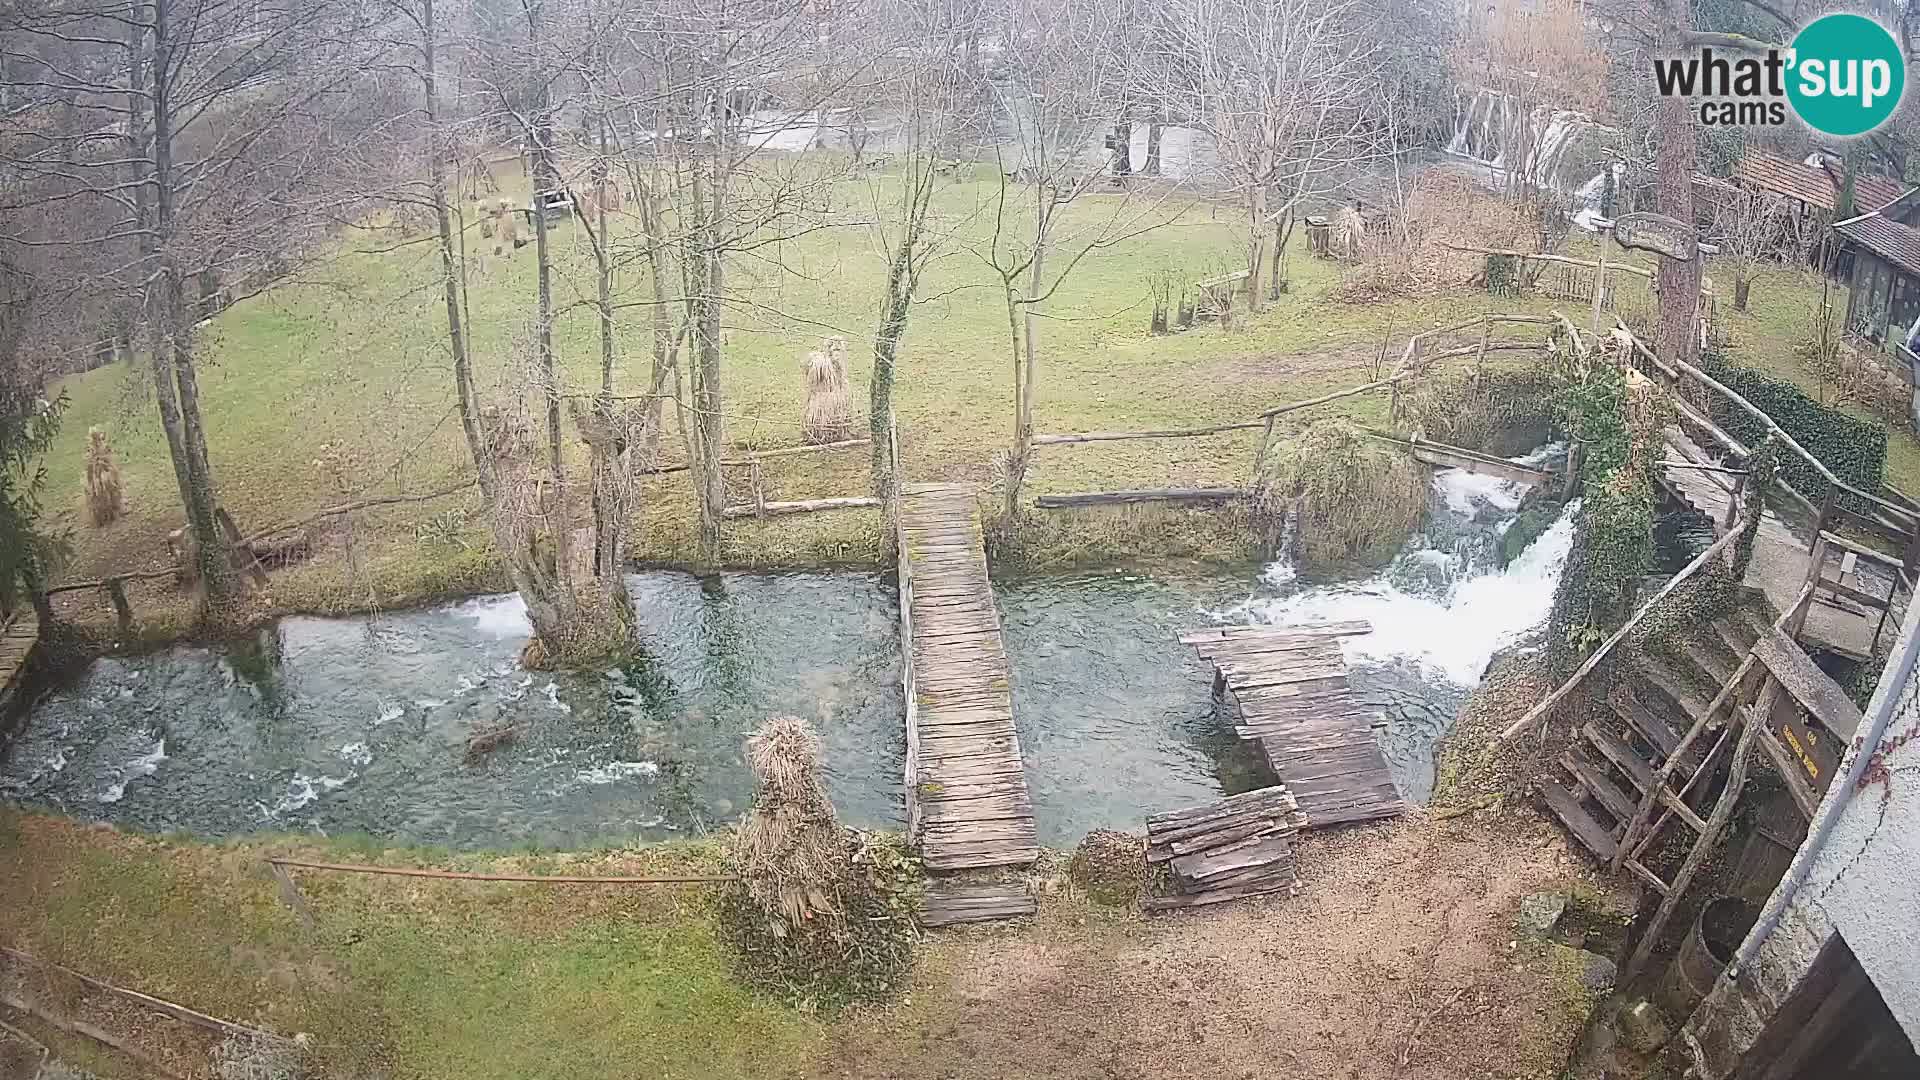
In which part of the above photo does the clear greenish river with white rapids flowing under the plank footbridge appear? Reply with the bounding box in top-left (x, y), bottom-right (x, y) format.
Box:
top-left (0, 449), bottom-right (1571, 849)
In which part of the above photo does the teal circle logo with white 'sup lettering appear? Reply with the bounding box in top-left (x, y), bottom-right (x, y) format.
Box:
top-left (1788, 15), bottom-right (1907, 136)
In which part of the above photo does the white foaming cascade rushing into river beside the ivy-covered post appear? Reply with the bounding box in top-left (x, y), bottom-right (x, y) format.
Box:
top-left (1244, 455), bottom-right (1576, 688)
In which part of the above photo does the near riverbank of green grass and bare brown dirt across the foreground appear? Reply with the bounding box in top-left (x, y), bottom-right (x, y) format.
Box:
top-left (0, 811), bottom-right (1620, 1080)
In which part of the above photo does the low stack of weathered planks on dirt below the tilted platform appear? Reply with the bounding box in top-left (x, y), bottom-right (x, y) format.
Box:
top-left (1142, 784), bottom-right (1308, 911)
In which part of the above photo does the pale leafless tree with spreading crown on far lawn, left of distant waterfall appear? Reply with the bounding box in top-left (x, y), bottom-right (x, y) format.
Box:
top-left (1165, 0), bottom-right (1394, 311)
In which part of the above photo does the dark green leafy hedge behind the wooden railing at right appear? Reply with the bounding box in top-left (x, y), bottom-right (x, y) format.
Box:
top-left (1699, 354), bottom-right (1887, 509)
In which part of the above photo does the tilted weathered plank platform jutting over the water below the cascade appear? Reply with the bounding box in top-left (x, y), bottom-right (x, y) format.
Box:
top-left (1181, 621), bottom-right (1407, 828)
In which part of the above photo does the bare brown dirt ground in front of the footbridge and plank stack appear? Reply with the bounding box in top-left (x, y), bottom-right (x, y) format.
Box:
top-left (822, 815), bottom-right (1586, 1080)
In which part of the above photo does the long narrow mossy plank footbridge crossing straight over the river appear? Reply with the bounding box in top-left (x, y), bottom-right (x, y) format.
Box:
top-left (897, 484), bottom-right (1041, 871)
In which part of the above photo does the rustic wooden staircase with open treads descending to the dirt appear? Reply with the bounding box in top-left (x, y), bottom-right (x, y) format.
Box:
top-left (1534, 609), bottom-right (1768, 896)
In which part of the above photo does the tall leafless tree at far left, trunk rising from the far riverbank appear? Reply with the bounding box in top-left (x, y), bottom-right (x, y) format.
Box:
top-left (0, 0), bottom-right (380, 605)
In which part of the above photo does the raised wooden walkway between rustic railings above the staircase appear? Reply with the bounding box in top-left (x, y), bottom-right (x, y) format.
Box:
top-left (1663, 427), bottom-right (1880, 659)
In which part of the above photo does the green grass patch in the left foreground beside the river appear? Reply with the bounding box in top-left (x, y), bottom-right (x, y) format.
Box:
top-left (0, 811), bottom-right (826, 1080)
